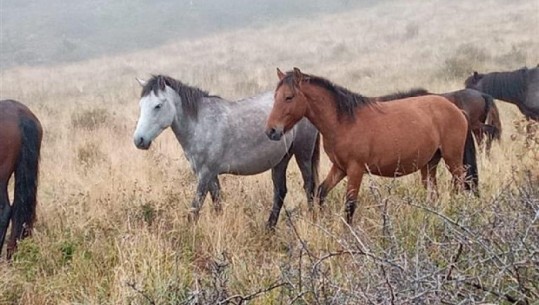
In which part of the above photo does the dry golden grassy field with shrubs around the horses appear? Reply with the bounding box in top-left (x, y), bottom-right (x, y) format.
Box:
top-left (0, 0), bottom-right (539, 304)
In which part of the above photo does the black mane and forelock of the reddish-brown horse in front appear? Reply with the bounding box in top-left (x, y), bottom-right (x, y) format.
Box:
top-left (277, 71), bottom-right (373, 118)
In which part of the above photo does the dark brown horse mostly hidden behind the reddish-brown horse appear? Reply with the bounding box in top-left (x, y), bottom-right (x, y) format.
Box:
top-left (375, 88), bottom-right (502, 152)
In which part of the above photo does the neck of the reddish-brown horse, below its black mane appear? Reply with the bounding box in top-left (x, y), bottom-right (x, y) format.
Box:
top-left (302, 84), bottom-right (346, 141)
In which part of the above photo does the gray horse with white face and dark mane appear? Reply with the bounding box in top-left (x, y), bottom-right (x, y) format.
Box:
top-left (134, 75), bottom-right (320, 229)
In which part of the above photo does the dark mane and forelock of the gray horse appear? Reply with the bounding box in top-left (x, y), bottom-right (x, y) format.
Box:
top-left (140, 75), bottom-right (212, 118)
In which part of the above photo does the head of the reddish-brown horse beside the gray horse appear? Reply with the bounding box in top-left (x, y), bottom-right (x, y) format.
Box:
top-left (266, 68), bottom-right (307, 141)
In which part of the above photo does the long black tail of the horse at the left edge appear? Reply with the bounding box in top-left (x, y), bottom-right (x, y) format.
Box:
top-left (7, 116), bottom-right (42, 258)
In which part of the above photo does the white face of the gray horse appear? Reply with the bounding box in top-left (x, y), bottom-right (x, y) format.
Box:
top-left (133, 86), bottom-right (177, 149)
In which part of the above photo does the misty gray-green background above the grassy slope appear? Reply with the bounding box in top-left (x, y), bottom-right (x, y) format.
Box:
top-left (0, 0), bottom-right (376, 69)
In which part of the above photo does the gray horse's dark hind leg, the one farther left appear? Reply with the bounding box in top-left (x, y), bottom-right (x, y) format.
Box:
top-left (266, 153), bottom-right (292, 230)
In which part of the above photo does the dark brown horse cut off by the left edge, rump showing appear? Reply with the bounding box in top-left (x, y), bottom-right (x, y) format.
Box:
top-left (0, 100), bottom-right (43, 259)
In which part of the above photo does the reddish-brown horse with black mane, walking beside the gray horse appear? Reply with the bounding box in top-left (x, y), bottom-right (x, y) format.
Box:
top-left (266, 68), bottom-right (478, 223)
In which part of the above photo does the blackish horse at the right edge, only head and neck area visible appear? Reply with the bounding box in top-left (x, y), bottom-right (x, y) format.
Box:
top-left (464, 67), bottom-right (539, 121)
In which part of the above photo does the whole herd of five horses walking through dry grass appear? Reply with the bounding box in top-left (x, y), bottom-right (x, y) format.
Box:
top-left (0, 67), bottom-right (539, 259)
